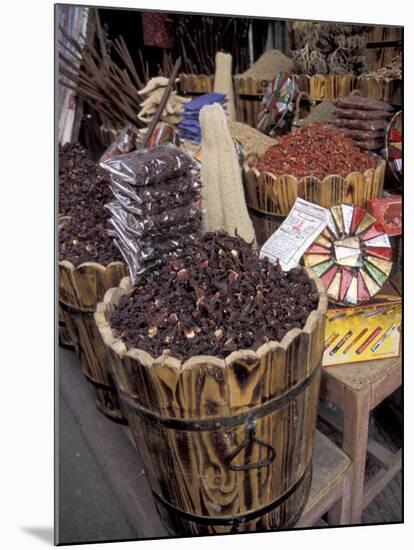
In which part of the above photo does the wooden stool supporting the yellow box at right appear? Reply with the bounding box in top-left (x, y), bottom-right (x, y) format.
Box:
top-left (319, 357), bottom-right (402, 524)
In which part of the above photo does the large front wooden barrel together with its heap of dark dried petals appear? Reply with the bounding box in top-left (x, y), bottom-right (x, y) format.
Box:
top-left (95, 232), bottom-right (327, 535)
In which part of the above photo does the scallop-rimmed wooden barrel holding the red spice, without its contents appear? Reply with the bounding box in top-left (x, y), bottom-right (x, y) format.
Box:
top-left (244, 160), bottom-right (385, 246)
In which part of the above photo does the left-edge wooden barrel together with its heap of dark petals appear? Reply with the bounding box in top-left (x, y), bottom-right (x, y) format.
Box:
top-left (59, 144), bottom-right (126, 422)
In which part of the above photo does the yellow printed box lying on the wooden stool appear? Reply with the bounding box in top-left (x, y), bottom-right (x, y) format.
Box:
top-left (322, 283), bottom-right (402, 367)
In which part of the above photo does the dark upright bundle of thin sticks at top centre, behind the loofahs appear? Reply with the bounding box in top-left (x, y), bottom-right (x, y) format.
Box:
top-left (170, 15), bottom-right (251, 74)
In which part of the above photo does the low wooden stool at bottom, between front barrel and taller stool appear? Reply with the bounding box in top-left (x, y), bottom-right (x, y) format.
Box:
top-left (295, 431), bottom-right (352, 527)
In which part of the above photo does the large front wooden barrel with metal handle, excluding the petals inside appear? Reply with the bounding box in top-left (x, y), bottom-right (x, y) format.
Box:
top-left (95, 270), bottom-right (327, 535)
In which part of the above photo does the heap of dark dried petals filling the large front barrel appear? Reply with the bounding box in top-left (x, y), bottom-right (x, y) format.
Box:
top-left (110, 232), bottom-right (318, 360)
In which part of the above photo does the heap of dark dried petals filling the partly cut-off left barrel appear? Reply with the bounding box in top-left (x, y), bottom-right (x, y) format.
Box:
top-left (59, 143), bottom-right (121, 265)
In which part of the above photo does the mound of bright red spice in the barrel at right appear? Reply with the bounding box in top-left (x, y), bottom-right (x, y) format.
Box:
top-left (255, 123), bottom-right (378, 179)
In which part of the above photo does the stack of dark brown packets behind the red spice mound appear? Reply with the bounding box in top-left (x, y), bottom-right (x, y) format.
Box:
top-left (332, 96), bottom-right (392, 151)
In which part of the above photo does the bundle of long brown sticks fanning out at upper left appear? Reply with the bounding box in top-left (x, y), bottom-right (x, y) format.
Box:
top-left (59, 10), bottom-right (149, 128)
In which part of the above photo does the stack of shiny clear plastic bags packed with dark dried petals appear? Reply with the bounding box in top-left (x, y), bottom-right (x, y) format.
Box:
top-left (100, 145), bottom-right (201, 282)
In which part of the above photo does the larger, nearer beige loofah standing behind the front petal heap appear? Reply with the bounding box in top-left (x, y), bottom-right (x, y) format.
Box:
top-left (200, 104), bottom-right (255, 242)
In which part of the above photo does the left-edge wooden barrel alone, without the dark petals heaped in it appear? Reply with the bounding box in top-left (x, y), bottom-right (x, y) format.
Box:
top-left (59, 220), bottom-right (126, 423)
